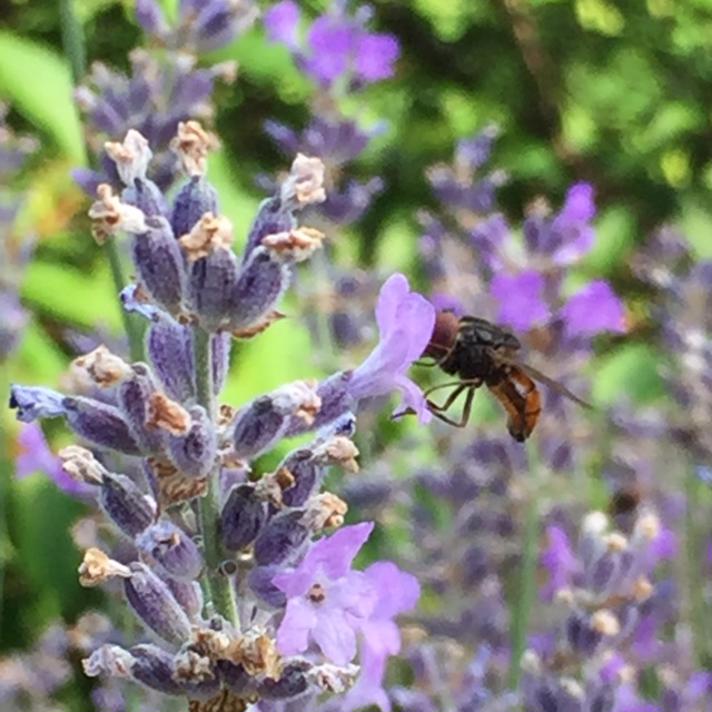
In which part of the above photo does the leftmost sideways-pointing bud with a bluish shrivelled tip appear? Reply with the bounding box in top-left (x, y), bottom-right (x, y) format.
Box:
top-left (63, 397), bottom-right (141, 455)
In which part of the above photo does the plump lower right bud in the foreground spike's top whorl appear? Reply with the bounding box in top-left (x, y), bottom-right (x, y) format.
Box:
top-left (229, 247), bottom-right (291, 331)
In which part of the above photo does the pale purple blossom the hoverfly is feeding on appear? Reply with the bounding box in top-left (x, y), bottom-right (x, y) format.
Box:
top-left (348, 273), bottom-right (435, 423)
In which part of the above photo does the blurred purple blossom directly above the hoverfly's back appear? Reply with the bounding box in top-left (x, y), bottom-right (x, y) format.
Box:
top-left (490, 270), bottom-right (550, 331)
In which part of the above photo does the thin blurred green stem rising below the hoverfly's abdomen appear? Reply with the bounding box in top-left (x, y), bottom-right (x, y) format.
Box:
top-left (509, 445), bottom-right (540, 690)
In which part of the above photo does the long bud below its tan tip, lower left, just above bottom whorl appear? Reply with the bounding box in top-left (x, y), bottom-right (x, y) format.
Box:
top-left (124, 562), bottom-right (190, 645)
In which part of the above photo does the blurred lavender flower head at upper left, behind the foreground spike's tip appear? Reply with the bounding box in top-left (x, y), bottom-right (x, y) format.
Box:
top-left (73, 0), bottom-right (253, 195)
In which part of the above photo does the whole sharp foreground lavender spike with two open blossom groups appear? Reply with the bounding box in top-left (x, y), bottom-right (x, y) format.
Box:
top-left (11, 121), bottom-right (434, 710)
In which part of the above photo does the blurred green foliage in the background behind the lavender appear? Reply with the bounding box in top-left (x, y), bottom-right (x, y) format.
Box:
top-left (0, 0), bottom-right (712, 710)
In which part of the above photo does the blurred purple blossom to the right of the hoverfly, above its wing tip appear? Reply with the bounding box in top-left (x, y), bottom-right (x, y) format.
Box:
top-left (560, 280), bottom-right (625, 337)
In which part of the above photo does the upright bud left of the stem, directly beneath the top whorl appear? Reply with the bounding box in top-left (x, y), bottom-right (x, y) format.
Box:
top-left (146, 315), bottom-right (195, 402)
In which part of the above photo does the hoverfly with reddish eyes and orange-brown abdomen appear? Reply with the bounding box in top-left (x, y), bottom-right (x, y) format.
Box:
top-left (423, 311), bottom-right (591, 442)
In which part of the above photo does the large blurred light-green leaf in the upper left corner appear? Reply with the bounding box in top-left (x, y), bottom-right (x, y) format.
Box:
top-left (0, 32), bottom-right (86, 164)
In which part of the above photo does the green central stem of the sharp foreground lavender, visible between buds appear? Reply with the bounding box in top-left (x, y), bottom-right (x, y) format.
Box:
top-left (193, 327), bottom-right (238, 625)
